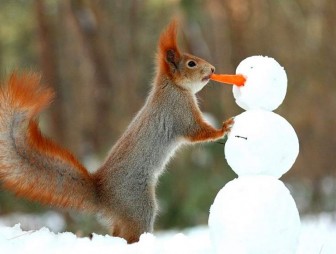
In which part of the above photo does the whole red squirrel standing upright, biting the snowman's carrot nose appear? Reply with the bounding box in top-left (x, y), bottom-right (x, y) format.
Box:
top-left (0, 22), bottom-right (233, 243)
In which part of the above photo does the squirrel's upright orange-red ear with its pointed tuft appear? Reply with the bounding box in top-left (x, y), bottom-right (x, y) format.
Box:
top-left (158, 20), bottom-right (181, 74)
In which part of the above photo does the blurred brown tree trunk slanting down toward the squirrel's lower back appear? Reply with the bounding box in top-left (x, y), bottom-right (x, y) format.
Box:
top-left (64, 0), bottom-right (114, 151)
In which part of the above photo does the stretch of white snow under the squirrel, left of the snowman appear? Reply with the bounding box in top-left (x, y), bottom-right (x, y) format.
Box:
top-left (0, 224), bottom-right (211, 254)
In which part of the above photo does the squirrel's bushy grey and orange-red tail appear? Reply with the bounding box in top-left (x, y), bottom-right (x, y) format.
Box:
top-left (0, 73), bottom-right (97, 211)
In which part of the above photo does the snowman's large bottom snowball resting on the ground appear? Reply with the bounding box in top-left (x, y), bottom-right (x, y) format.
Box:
top-left (209, 176), bottom-right (300, 254)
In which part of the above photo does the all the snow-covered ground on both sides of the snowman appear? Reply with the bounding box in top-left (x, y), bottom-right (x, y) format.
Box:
top-left (0, 214), bottom-right (336, 254)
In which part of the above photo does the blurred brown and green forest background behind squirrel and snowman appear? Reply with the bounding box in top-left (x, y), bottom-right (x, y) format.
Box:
top-left (0, 0), bottom-right (336, 232)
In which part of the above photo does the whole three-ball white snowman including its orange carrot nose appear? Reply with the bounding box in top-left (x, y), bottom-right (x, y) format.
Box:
top-left (209, 56), bottom-right (300, 254)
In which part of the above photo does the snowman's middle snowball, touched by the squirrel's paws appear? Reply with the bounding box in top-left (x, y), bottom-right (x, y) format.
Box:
top-left (224, 110), bottom-right (299, 178)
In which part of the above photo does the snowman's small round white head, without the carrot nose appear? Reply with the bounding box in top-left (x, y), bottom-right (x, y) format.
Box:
top-left (233, 56), bottom-right (287, 111)
